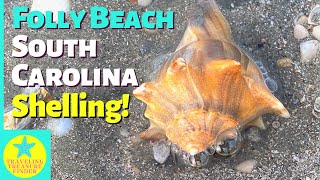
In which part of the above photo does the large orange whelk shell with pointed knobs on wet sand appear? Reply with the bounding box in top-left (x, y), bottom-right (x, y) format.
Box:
top-left (133, 1), bottom-right (289, 166)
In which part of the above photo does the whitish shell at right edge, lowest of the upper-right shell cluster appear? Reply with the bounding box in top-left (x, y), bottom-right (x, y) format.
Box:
top-left (300, 40), bottom-right (320, 63)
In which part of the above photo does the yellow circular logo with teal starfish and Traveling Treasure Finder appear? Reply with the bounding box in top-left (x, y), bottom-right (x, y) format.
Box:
top-left (3, 135), bottom-right (46, 178)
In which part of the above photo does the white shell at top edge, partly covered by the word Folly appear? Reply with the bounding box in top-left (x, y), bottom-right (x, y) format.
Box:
top-left (31, 0), bottom-right (71, 22)
